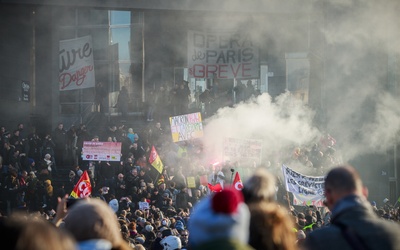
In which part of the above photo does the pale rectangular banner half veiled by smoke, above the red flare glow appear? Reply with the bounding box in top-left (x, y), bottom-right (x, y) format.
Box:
top-left (223, 138), bottom-right (262, 164)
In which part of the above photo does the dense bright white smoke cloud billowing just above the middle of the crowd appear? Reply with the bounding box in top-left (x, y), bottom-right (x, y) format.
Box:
top-left (203, 93), bottom-right (321, 169)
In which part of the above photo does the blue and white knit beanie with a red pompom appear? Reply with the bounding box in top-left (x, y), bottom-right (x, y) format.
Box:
top-left (188, 188), bottom-right (250, 246)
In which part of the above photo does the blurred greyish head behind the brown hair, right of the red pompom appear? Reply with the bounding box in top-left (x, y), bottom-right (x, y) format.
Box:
top-left (242, 168), bottom-right (276, 204)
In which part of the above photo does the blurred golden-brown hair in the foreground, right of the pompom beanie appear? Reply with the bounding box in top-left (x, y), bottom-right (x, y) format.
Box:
top-left (249, 202), bottom-right (297, 250)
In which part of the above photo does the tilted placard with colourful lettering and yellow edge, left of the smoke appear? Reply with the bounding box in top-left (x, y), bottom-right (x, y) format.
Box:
top-left (169, 112), bottom-right (203, 142)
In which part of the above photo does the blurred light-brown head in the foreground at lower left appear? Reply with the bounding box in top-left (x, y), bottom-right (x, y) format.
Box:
top-left (64, 199), bottom-right (129, 249)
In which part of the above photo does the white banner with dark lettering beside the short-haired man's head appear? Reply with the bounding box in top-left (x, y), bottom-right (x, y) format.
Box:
top-left (282, 165), bottom-right (325, 207)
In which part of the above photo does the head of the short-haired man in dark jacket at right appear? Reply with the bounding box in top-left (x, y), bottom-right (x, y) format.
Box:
top-left (325, 165), bottom-right (368, 211)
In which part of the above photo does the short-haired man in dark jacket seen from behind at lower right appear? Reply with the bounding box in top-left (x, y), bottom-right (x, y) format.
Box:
top-left (305, 165), bottom-right (400, 250)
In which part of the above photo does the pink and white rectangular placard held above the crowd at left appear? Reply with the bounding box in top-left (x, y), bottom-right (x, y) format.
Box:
top-left (82, 141), bottom-right (122, 161)
